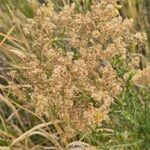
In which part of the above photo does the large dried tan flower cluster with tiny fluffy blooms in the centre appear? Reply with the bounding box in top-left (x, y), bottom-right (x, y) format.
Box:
top-left (7, 0), bottom-right (145, 134)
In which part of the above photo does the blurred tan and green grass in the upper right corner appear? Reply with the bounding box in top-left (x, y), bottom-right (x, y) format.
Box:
top-left (122, 0), bottom-right (150, 60)
